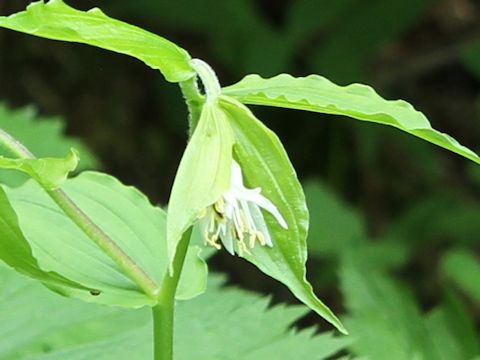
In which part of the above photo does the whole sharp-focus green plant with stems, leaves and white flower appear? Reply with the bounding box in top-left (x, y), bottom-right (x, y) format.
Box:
top-left (0, 0), bottom-right (480, 359)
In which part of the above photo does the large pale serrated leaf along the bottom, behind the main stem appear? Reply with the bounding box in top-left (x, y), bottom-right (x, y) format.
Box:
top-left (0, 268), bottom-right (349, 360)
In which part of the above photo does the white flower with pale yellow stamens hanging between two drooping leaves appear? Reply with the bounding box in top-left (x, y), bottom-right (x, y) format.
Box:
top-left (199, 161), bottom-right (288, 255)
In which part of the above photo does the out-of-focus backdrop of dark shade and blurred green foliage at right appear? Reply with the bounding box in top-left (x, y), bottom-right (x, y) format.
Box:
top-left (0, 0), bottom-right (480, 360)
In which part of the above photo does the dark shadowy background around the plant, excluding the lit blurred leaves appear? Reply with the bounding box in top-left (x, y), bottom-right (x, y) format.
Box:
top-left (0, 0), bottom-right (480, 336)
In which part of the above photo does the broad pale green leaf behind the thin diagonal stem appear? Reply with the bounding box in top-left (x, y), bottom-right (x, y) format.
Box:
top-left (7, 172), bottom-right (206, 307)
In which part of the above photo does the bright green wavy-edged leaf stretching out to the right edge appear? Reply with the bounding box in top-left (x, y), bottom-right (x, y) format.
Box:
top-left (223, 74), bottom-right (480, 163)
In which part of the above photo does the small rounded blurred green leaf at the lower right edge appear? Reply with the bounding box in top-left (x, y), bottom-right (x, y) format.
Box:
top-left (442, 249), bottom-right (480, 303)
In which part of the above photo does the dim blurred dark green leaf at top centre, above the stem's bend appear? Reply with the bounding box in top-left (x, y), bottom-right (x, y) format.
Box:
top-left (115, 0), bottom-right (292, 74)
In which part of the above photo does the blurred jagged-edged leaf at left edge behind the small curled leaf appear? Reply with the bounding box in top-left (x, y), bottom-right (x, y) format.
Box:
top-left (0, 103), bottom-right (99, 187)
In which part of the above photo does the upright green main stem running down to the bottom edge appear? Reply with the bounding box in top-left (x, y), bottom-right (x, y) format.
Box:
top-left (152, 228), bottom-right (192, 360)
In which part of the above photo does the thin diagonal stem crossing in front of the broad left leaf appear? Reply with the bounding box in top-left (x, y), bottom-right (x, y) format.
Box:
top-left (0, 129), bottom-right (160, 299)
